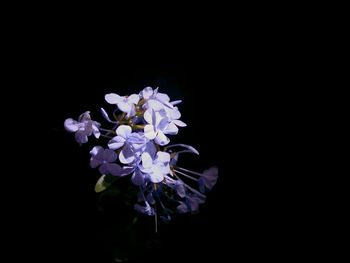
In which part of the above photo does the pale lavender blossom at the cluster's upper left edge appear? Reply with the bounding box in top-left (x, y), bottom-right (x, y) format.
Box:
top-left (105, 93), bottom-right (140, 117)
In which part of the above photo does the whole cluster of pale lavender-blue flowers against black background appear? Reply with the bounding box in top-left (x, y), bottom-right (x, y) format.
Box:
top-left (64, 87), bottom-right (218, 230)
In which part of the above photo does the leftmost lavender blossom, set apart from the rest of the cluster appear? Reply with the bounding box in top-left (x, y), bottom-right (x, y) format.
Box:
top-left (64, 111), bottom-right (101, 144)
